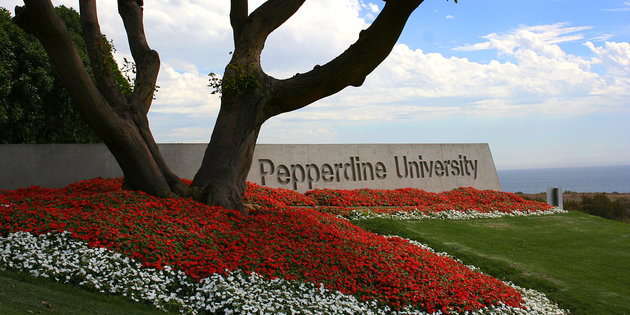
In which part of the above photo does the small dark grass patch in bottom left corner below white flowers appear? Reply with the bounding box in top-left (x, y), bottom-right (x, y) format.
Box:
top-left (0, 270), bottom-right (163, 315)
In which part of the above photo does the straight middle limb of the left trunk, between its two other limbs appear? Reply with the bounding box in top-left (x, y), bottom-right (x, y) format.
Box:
top-left (79, 0), bottom-right (126, 108)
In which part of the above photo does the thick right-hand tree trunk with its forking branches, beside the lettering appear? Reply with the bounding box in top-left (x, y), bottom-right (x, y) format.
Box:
top-left (193, 0), bottom-right (422, 209)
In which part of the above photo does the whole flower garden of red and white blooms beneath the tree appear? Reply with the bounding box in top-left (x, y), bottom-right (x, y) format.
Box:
top-left (0, 178), bottom-right (562, 314)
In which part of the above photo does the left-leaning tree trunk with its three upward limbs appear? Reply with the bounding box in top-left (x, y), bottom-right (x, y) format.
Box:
top-left (14, 0), bottom-right (186, 197)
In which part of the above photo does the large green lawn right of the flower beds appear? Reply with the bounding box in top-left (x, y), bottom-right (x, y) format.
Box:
top-left (353, 212), bottom-right (630, 314)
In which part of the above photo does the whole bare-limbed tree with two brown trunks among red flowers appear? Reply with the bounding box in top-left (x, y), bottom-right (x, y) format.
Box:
top-left (14, 0), bottom-right (452, 211)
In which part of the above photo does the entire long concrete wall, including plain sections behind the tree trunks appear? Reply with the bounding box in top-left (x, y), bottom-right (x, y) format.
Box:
top-left (0, 144), bottom-right (501, 192)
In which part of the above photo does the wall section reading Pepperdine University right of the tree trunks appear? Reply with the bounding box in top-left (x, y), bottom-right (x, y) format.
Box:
top-left (248, 143), bottom-right (501, 192)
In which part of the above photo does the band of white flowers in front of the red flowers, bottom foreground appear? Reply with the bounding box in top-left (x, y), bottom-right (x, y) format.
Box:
top-left (0, 232), bottom-right (563, 314)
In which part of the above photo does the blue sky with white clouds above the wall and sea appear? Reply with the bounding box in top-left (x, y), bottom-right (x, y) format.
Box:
top-left (0, 0), bottom-right (630, 170)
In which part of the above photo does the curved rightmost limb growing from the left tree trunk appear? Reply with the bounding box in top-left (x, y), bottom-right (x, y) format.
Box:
top-left (118, 0), bottom-right (160, 115)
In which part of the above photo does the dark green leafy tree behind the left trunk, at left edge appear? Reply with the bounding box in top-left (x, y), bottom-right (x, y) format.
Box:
top-left (0, 6), bottom-right (100, 143)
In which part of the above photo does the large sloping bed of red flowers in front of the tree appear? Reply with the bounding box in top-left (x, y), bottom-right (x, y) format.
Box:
top-left (0, 179), bottom-right (522, 312)
